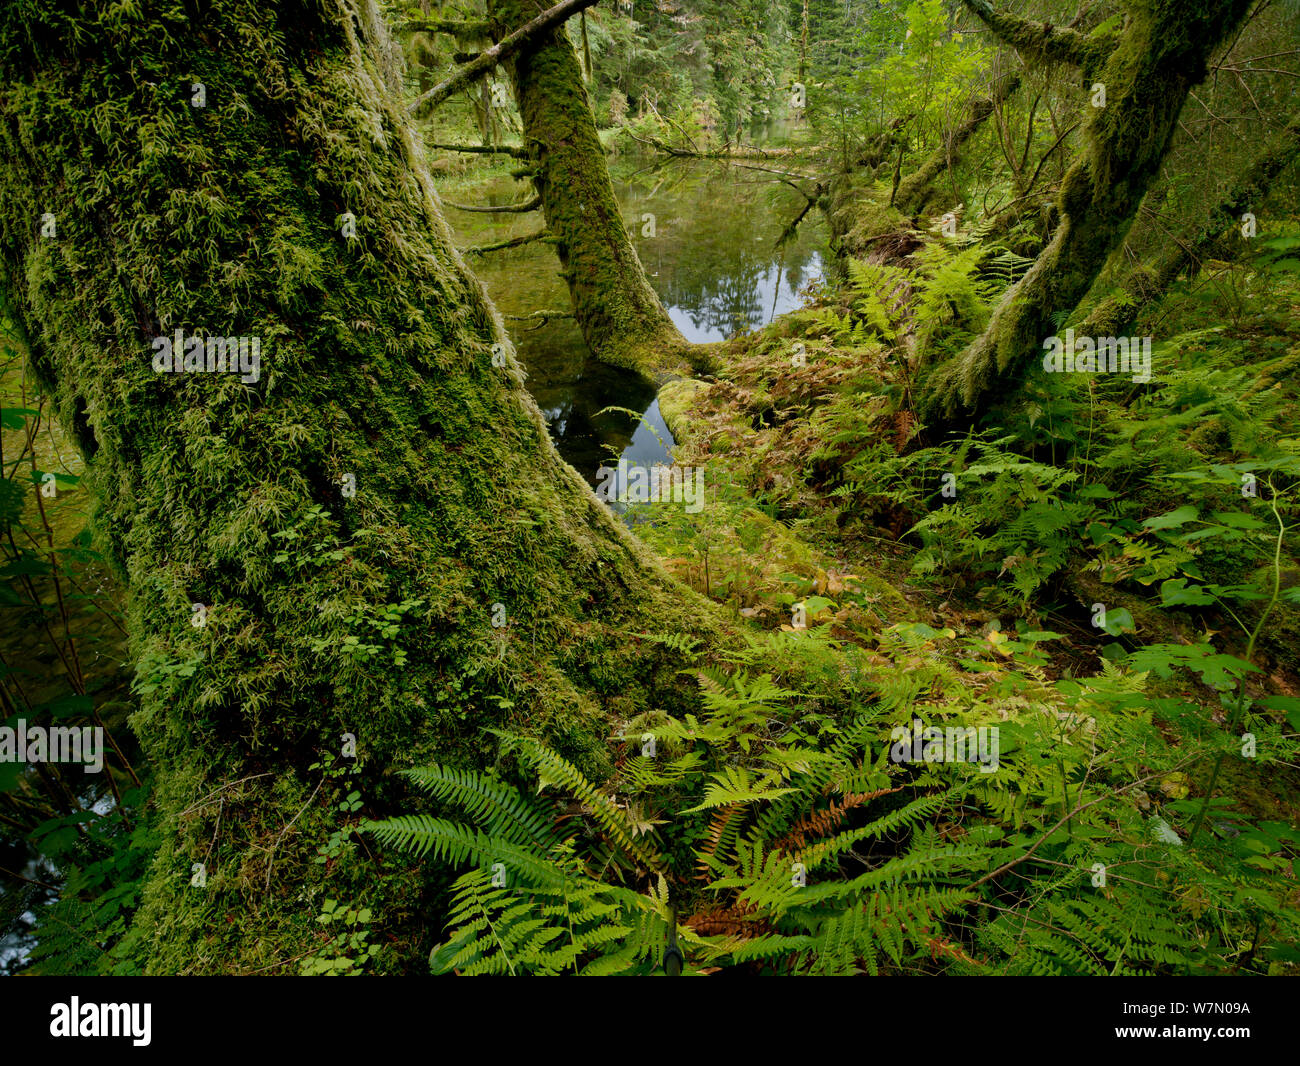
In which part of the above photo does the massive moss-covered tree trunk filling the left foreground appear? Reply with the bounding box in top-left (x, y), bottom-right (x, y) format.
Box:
top-left (0, 0), bottom-right (714, 972)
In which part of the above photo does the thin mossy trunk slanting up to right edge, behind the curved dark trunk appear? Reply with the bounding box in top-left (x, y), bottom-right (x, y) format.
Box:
top-left (1075, 109), bottom-right (1300, 337)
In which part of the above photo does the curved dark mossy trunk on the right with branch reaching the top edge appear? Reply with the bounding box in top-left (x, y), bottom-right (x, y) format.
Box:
top-left (922, 0), bottom-right (1255, 421)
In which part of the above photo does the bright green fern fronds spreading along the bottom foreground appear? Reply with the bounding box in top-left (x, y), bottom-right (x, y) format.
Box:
top-left (368, 608), bottom-right (1300, 974)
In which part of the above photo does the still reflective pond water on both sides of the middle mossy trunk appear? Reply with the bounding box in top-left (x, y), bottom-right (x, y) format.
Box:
top-left (446, 156), bottom-right (827, 484)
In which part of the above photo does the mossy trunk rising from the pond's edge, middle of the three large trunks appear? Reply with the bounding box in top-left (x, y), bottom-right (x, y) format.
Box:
top-left (489, 0), bottom-right (706, 376)
